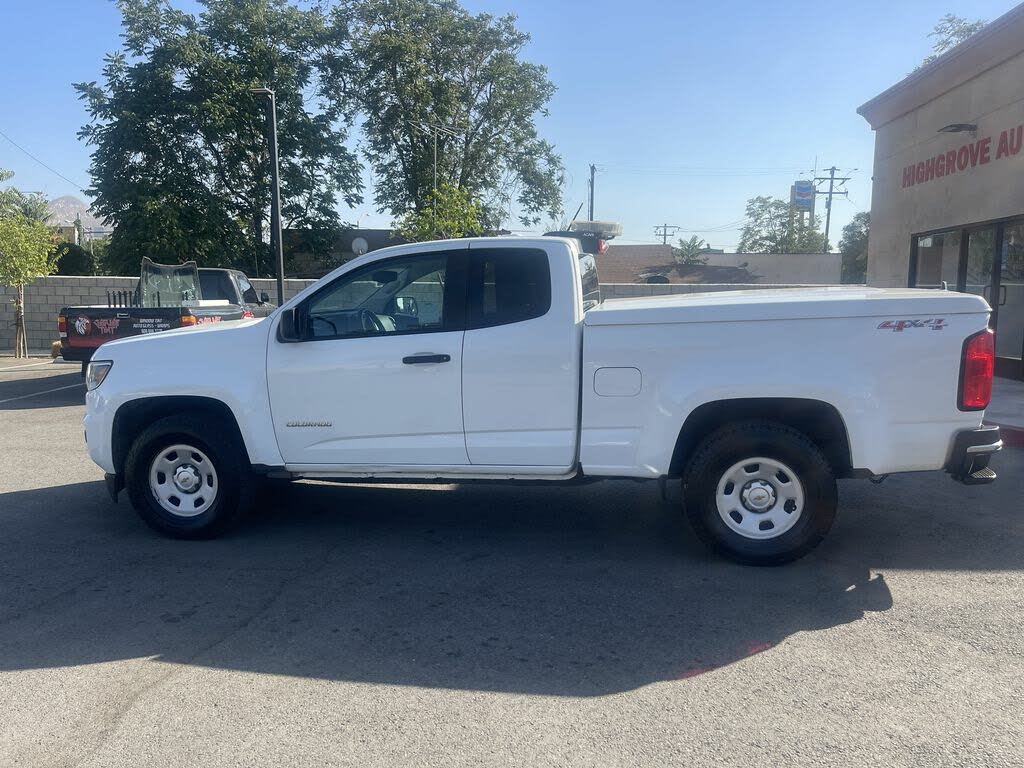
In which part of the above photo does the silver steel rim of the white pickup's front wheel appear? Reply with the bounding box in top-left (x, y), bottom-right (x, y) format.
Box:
top-left (150, 443), bottom-right (220, 517)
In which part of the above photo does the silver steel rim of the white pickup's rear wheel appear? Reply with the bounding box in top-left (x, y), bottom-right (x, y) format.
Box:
top-left (715, 456), bottom-right (805, 541)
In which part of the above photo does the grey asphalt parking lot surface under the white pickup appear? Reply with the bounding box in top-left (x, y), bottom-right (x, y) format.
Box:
top-left (0, 359), bottom-right (1024, 767)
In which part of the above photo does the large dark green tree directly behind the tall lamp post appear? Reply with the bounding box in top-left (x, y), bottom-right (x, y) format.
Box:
top-left (75, 0), bottom-right (360, 274)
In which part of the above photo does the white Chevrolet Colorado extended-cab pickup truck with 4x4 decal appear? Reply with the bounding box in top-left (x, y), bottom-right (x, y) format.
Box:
top-left (85, 238), bottom-right (1001, 564)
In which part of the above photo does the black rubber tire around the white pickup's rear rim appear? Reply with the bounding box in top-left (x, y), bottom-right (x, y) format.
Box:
top-left (683, 421), bottom-right (837, 565)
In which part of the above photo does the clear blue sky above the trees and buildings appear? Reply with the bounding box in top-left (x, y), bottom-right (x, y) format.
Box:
top-left (0, 0), bottom-right (1014, 250)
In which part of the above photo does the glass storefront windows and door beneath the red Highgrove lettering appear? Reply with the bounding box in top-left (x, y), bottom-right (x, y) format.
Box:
top-left (910, 219), bottom-right (1024, 379)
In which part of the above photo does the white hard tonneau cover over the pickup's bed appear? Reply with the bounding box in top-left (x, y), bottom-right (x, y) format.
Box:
top-left (585, 286), bottom-right (990, 326)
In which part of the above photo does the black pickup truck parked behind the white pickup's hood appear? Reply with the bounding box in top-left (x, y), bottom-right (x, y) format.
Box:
top-left (57, 258), bottom-right (274, 371)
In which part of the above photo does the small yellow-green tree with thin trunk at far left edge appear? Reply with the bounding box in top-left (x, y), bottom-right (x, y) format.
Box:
top-left (0, 212), bottom-right (56, 357)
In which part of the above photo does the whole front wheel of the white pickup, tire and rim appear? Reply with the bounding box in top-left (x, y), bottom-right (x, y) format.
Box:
top-left (125, 416), bottom-right (249, 539)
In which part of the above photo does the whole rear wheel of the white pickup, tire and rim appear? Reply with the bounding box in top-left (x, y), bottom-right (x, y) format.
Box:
top-left (683, 421), bottom-right (837, 565)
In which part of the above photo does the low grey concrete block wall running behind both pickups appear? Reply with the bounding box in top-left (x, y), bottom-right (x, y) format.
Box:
top-left (0, 276), bottom-right (839, 354)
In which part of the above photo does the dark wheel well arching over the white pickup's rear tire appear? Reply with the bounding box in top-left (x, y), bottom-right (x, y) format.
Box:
top-left (669, 397), bottom-right (853, 477)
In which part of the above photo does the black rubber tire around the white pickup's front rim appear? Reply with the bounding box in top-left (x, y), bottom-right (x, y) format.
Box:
top-left (125, 414), bottom-right (252, 539)
